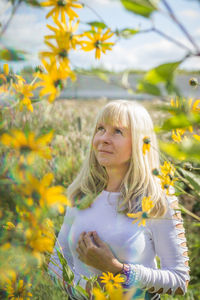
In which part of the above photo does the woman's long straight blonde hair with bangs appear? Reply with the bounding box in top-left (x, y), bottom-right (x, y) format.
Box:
top-left (67, 100), bottom-right (166, 217)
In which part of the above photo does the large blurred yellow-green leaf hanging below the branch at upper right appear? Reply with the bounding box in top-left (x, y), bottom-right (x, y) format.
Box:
top-left (144, 60), bottom-right (182, 84)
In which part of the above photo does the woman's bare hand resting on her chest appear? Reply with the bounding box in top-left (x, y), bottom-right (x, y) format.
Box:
top-left (76, 231), bottom-right (123, 274)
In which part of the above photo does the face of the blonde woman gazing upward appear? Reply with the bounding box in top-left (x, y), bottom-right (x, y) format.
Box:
top-left (93, 123), bottom-right (132, 168)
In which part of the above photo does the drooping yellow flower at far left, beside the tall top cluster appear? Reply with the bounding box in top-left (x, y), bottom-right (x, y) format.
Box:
top-left (12, 80), bottom-right (36, 112)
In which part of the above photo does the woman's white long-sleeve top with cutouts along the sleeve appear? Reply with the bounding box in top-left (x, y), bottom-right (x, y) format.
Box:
top-left (49, 190), bottom-right (189, 294)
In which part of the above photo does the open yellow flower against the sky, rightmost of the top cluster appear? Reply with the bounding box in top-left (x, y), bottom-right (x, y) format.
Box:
top-left (82, 27), bottom-right (114, 59)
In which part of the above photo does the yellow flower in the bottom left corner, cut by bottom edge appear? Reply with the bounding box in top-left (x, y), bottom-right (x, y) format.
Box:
top-left (4, 273), bottom-right (32, 300)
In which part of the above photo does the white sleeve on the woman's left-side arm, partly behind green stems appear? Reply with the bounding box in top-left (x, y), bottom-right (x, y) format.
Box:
top-left (48, 207), bottom-right (80, 283)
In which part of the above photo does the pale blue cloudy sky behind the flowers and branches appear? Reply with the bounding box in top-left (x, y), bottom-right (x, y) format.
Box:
top-left (0, 0), bottom-right (200, 71)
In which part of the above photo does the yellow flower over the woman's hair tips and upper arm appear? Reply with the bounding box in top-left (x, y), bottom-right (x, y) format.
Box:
top-left (127, 197), bottom-right (154, 226)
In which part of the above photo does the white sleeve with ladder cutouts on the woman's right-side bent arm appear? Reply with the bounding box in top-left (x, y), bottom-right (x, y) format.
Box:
top-left (132, 192), bottom-right (190, 295)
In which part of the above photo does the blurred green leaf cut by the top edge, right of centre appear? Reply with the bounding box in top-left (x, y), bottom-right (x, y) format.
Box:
top-left (121, 0), bottom-right (158, 18)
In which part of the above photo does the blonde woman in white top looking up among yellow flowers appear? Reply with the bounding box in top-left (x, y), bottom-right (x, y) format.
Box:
top-left (49, 100), bottom-right (189, 299)
